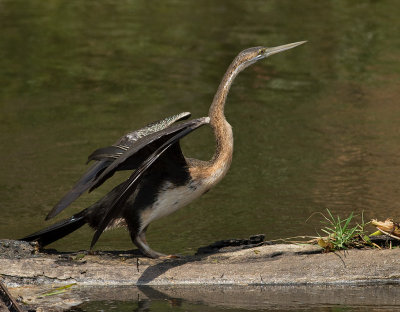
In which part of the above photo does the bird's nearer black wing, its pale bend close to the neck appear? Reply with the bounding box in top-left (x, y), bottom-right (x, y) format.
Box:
top-left (90, 117), bottom-right (210, 248)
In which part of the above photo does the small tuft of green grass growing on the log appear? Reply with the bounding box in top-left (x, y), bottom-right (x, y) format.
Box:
top-left (318, 209), bottom-right (370, 251)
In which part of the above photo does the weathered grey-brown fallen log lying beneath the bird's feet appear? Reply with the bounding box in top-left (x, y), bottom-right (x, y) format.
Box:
top-left (0, 241), bottom-right (400, 311)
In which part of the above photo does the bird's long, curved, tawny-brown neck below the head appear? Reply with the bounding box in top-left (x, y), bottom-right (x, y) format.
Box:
top-left (208, 61), bottom-right (240, 178)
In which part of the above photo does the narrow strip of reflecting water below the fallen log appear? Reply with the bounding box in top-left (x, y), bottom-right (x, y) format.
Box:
top-left (65, 285), bottom-right (400, 312)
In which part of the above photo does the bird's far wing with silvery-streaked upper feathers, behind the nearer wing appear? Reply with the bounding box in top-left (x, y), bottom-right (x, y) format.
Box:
top-left (46, 112), bottom-right (190, 220)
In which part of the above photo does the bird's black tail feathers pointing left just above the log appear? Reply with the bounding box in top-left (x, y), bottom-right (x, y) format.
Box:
top-left (20, 210), bottom-right (86, 247)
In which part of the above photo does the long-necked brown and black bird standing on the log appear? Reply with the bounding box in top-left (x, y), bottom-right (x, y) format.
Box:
top-left (21, 41), bottom-right (306, 258)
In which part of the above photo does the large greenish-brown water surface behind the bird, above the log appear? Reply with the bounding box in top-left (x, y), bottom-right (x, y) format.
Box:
top-left (0, 0), bottom-right (400, 310)
